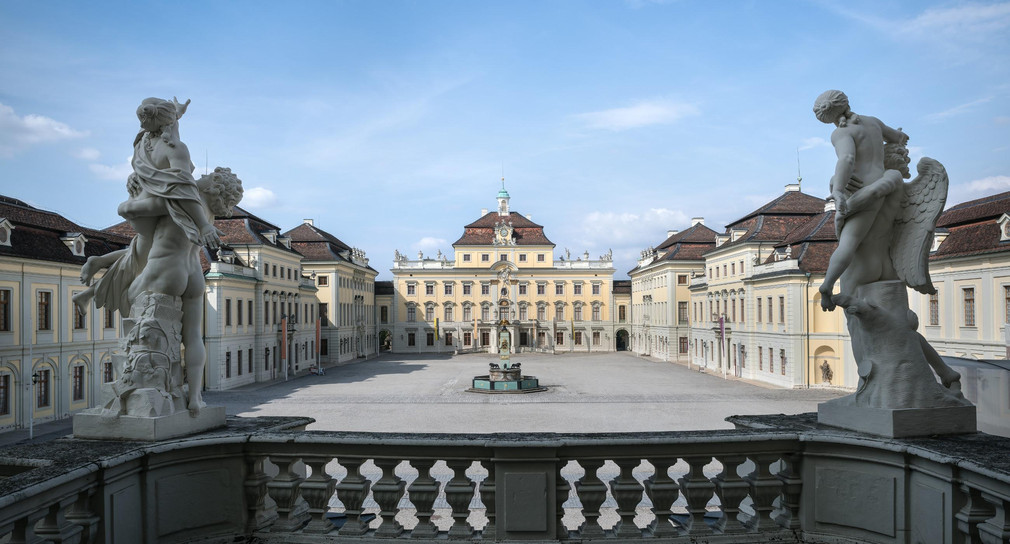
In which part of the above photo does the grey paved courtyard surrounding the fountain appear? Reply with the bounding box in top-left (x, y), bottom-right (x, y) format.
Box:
top-left (205, 352), bottom-right (844, 433)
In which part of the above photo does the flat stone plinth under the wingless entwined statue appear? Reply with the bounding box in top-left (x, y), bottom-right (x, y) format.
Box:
top-left (74, 406), bottom-right (225, 441)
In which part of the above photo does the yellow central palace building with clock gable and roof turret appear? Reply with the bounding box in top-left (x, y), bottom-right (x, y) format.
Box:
top-left (380, 188), bottom-right (630, 353)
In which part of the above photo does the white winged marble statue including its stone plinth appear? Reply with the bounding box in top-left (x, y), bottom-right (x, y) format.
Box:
top-left (814, 91), bottom-right (976, 437)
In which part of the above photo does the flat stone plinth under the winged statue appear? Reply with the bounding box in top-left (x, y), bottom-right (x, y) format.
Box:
top-left (817, 397), bottom-right (978, 438)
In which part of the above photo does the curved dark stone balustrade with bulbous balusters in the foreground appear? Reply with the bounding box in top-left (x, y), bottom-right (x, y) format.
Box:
top-left (0, 415), bottom-right (1010, 543)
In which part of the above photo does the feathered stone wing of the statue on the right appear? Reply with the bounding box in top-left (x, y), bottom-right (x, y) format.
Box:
top-left (891, 156), bottom-right (948, 295)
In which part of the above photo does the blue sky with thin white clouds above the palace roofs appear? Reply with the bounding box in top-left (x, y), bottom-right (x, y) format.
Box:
top-left (0, 0), bottom-right (1010, 280)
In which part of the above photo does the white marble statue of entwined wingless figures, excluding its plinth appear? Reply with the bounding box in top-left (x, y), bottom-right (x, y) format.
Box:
top-left (74, 98), bottom-right (242, 438)
